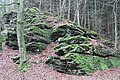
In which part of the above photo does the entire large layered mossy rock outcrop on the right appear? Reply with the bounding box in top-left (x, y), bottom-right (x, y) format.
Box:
top-left (47, 24), bottom-right (120, 75)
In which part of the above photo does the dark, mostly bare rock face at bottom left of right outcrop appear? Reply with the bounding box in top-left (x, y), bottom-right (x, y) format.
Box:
top-left (46, 56), bottom-right (85, 75)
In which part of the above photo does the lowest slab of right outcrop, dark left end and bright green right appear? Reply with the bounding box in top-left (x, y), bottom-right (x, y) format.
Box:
top-left (46, 53), bottom-right (120, 75)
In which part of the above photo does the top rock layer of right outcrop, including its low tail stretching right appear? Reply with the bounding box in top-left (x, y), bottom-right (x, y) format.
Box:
top-left (51, 23), bottom-right (99, 41)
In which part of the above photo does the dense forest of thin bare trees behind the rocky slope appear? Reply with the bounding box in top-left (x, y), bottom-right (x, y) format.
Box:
top-left (0, 0), bottom-right (120, 48)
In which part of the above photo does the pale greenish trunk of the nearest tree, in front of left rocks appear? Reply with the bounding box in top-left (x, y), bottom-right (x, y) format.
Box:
top-left (17, 0), bottom-right (27, 69)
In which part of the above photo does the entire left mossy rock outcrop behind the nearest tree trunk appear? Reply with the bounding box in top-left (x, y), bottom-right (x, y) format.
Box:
top-left (3, 8), bottom-right (52, 53)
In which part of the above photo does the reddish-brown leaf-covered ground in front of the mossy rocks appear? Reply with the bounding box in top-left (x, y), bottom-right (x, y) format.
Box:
top-left (0, 43), bottom-right (120, 80)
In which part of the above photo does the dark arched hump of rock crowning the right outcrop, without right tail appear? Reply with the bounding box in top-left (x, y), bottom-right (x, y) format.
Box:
top-left (51, 24), bottom-right (85, 41)
